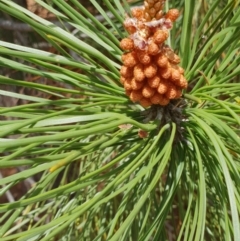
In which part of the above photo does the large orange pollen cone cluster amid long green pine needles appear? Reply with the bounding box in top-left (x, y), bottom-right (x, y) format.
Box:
top-left (120, 0), bottom-right (188, 107)
